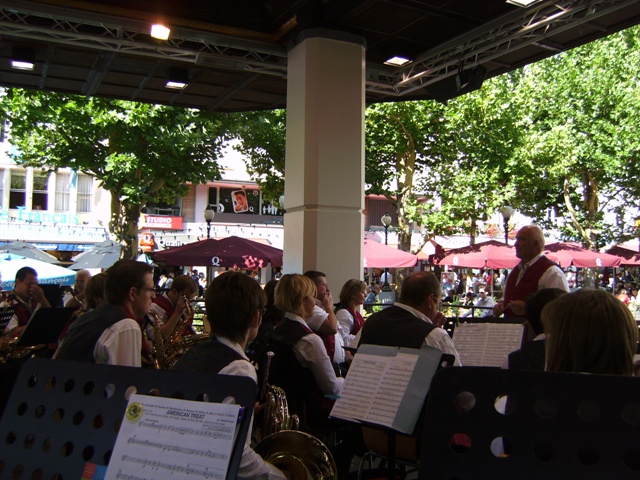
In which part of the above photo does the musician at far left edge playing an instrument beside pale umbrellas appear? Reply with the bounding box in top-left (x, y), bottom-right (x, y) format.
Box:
top-left (0, 267), bottom-right (51, 337)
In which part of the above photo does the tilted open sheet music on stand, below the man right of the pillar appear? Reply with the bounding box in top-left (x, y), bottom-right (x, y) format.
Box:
top-left (331, 345), bottom-right (442, 434)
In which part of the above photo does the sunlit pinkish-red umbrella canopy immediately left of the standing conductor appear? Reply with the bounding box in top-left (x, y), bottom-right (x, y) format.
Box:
top-left (431, 240), bottom-right (520, 269)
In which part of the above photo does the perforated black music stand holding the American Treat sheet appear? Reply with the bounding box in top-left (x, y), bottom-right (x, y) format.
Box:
top-left (0, 358), bottom-right (256, 480)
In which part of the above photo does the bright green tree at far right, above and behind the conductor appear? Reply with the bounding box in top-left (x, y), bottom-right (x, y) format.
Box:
top-left (511, 27), bottom-right (640, 247)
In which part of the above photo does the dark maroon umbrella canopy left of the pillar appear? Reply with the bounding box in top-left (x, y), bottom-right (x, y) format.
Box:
top-left (154, 236), bottom-right (282, 268)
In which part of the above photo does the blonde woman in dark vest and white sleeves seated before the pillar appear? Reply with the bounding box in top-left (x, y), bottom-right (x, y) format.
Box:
top-left (270, 274), bottom-right (344, 426)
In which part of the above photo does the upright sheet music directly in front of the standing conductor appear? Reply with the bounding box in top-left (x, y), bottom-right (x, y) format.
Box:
top-left (453, 323), bottom-right (524, 367)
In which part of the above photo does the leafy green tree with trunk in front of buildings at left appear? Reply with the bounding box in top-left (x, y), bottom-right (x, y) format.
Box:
top-left (0, 89), bottom-right (228, 258)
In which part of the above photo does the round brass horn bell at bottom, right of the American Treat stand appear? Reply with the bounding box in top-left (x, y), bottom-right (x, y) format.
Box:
top-left (255, 430), bottom-right (338, 480)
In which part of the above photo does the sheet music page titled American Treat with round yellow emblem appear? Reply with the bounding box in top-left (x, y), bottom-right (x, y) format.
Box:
top-left (106, 395), bottom-right (241, 480)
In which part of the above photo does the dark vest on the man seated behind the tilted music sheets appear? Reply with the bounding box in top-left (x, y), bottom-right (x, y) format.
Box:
top-left (360, 305), bottom-right (436, 348)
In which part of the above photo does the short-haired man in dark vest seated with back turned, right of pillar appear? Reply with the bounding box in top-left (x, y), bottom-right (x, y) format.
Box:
top-left (360, 272), bottom-right (460, 365)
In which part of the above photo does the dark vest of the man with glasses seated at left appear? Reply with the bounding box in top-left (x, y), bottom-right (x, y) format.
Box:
top-left (56, 303), bottom-right (128, 363)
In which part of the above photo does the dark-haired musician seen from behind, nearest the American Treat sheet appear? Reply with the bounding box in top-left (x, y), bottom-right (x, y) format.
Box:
top-left (172, 272), bottom-right (286, 479)
